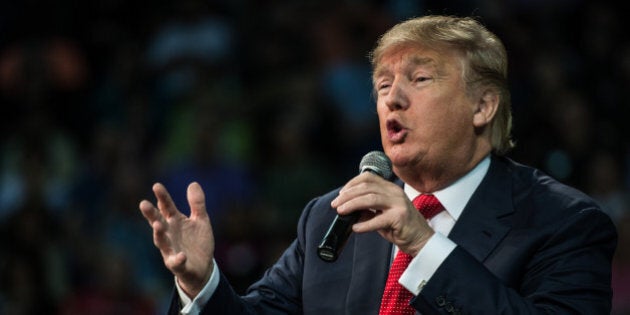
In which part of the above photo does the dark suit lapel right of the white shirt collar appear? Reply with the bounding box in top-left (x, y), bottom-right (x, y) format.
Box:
top-left (448, 156), bottom-right (514, 261)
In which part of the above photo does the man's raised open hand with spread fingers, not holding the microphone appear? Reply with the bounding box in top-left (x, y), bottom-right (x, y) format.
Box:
top-left (139, 183), bottom-right (215, 298)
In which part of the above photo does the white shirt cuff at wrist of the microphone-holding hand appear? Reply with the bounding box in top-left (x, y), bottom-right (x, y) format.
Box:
top-left (398, 232), bottom-right (457, 295)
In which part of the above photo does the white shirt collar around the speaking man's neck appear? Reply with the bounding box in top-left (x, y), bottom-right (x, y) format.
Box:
top-left (404, 155), bottom-right (490, 220)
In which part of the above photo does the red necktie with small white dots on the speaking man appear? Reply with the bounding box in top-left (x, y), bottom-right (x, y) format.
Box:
top-left (379, 195), bottom-right (444, 315)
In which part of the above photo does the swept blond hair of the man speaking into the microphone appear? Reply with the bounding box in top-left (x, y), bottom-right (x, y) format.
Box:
top-left (370, 16), bottom-right (514, 155)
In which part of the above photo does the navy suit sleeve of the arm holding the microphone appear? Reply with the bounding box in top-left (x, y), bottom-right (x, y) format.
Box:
top-left (412, 208), bottom-right (616, 314)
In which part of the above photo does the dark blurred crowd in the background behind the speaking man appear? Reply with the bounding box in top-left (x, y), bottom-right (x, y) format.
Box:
top-left (0, 0), bottom-right (630, 314)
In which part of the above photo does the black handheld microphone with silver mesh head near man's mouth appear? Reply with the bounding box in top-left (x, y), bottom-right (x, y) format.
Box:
top-left (317, 151), bottom-right (392, 262)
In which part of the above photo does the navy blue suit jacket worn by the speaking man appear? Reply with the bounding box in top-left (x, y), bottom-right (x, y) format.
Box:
top-left (172, 156), bottom-right (617, 315)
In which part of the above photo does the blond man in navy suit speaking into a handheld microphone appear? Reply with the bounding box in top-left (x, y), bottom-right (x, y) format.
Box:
top-left (140, 16), bottom-right (616, 314)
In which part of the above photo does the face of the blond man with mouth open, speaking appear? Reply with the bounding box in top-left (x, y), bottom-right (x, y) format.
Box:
top-left (373, 45), bottom-right (478, 188)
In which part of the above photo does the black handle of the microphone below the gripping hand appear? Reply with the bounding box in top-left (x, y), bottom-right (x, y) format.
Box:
top-left (317, 211), bottom-right (361, 262)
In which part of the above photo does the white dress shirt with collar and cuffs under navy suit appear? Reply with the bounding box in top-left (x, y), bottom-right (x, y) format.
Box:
top-left (175, 156), bottom-right (490, 315)
